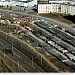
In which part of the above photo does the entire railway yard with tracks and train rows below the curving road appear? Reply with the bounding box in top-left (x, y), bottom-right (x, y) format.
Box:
top-left (0, 10), bottom-right (75, 73)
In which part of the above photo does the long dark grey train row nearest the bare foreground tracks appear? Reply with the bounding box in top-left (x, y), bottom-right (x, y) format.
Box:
top-left (28, 35), bottom-right (75, 72)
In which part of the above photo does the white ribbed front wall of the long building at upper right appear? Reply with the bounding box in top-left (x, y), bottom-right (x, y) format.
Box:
top-left (38, 4), bottom-right (75, 15)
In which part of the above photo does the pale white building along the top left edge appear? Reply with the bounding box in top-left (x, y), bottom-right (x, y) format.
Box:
top-left (0, 0), bottom-right (37, 7)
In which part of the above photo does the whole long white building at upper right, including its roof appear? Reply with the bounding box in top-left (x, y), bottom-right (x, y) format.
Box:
top-left (38, 0), bottom-right (75, 15)
